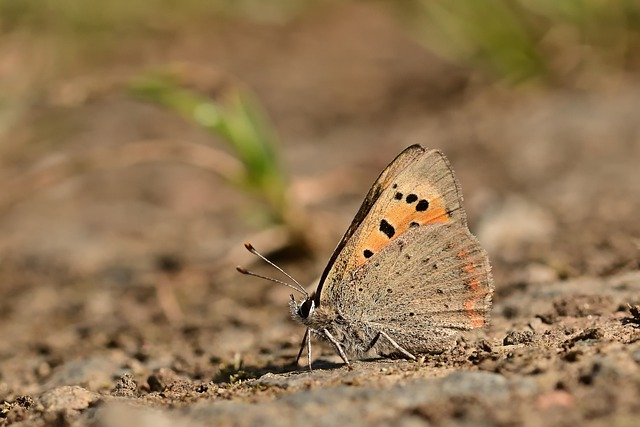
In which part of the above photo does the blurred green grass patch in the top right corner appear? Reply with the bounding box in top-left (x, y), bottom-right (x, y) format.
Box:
top-left (385, 0), bottom-right (640, 85)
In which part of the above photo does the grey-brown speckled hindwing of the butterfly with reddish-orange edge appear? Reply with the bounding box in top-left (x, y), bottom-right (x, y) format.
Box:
top-left (332, 223), bottom-right (493, 353)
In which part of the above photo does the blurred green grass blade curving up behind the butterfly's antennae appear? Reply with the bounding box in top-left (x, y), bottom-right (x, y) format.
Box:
top-left (130, 67), bottom-right (300, 234)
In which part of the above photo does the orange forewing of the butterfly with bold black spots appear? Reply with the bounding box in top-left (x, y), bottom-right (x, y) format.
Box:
top-left (315, 145), bottom-right (466, 306)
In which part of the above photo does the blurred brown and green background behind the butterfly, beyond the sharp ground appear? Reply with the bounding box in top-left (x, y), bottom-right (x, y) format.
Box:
top-left (0, 0), bottom-right (640, 398)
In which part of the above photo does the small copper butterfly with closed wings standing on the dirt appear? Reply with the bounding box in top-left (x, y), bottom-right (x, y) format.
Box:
top-left (238, 145), bottom-right (494, 369)
